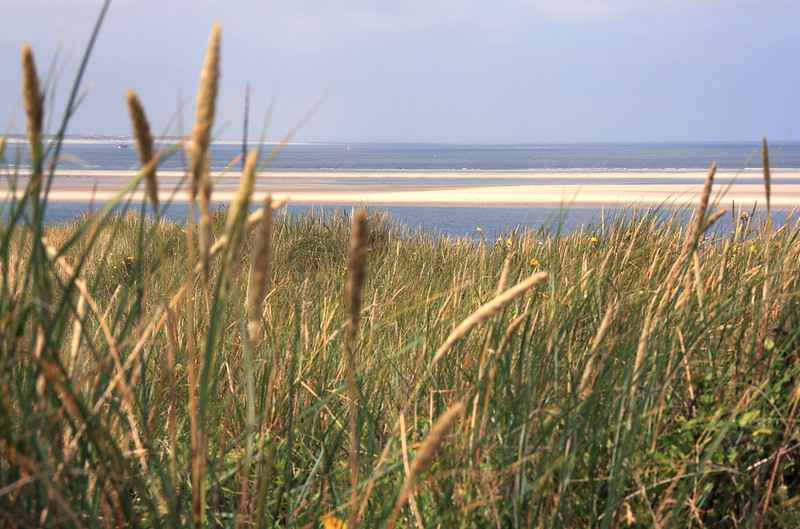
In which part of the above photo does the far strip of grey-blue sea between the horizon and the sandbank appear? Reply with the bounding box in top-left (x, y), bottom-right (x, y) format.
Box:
top-left (28, 140), bottom-right (800, 172)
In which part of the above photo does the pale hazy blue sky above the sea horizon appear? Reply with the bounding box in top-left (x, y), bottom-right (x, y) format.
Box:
top-left (0, 0), bottom-right (800, 143)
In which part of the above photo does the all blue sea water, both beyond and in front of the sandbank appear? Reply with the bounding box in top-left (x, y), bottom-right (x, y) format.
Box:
top-left (6, 137), bottom-right (800, 237)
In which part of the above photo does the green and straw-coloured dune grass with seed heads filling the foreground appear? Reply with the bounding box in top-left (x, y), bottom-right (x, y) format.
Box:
top-left (0, 11), bottom-right (800, 527)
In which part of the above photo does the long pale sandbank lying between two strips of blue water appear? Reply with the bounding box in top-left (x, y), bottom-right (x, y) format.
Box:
top-left (17, 170), bottom-right (800, 208)
